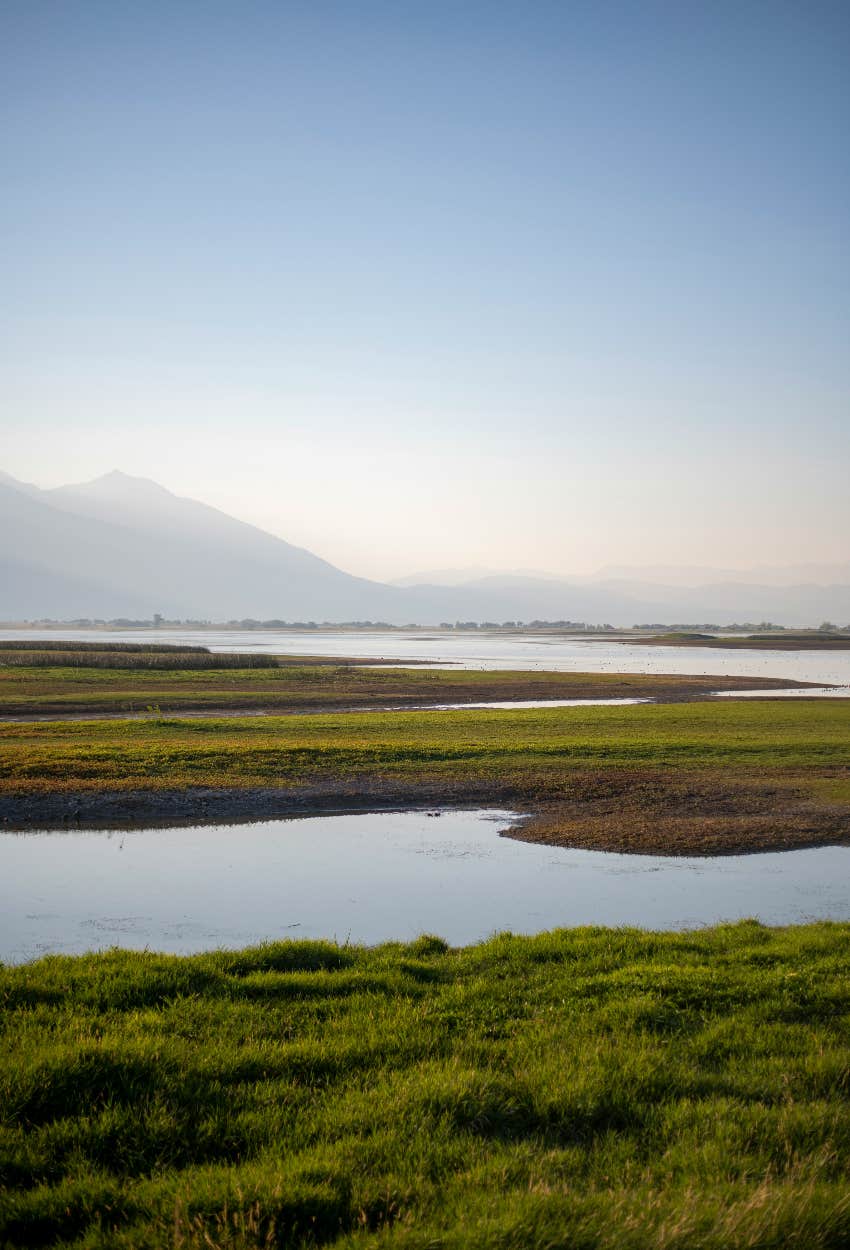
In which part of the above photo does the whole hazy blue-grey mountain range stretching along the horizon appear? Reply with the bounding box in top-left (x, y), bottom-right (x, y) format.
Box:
top-left (0, 471), bottom-right (850, 625)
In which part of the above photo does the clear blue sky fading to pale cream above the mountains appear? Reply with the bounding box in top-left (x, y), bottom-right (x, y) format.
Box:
top-left (0, 0), bottom-right (850, 579)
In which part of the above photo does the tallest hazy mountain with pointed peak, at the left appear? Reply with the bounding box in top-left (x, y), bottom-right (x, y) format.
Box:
top-left (0, 473), bottom-right (401, 620)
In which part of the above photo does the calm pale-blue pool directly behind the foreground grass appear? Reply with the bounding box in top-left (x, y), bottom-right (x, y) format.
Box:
top-left (0, 811), bottom-right (850, 963)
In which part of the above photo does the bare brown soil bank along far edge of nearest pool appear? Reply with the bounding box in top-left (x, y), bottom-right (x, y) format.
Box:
top-left (0, 769), bottom-right (850, 856)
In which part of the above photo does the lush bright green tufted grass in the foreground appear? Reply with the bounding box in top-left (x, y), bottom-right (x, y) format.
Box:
top-left (0, 923), bottom-right (850, 1250)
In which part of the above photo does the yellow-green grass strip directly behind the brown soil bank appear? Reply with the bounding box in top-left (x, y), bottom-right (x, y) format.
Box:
top-left (0, 700), bottom-right (850, 794)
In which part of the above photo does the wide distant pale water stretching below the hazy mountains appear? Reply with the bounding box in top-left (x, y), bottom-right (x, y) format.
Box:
top-left (0, 629), bottom-right (850, 694)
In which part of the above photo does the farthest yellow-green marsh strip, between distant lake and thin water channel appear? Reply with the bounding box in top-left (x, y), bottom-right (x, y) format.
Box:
top-left (0, 651), bottom-right (799, 716)
